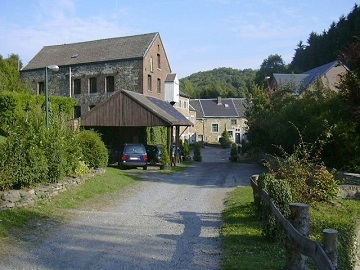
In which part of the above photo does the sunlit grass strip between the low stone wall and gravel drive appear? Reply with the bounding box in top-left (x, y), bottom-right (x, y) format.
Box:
top-left (0, 168), bottom-right (136, 242)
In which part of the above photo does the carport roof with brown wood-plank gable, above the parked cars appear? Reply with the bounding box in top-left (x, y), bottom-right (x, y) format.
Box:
top-left (81, 90), bottom-right (193, 127)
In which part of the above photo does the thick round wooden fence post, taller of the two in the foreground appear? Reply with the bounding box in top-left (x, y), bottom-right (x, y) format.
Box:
top-left (286, 203), bottom-right (310, 270)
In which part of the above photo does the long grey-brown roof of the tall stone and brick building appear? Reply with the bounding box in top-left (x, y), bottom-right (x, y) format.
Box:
top-left (22, 33), bottom-right (159, 70)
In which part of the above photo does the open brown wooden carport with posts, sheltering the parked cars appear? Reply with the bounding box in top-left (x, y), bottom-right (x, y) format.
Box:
top-left (80, 90), bottom-right (193, 161)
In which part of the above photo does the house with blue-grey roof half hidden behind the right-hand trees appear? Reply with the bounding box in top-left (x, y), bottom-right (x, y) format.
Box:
top-left (269, 61), bottom-right (348, 95)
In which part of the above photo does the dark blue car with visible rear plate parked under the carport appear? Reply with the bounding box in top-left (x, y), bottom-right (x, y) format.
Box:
top-left (118, 144), bottom-right (148, 170)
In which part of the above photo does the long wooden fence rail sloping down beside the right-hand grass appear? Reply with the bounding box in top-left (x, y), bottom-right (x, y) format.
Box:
top-left (250, 175), bottom-right (337, 270)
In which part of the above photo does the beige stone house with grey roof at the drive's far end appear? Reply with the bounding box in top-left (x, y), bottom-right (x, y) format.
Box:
top-left (190, 97), bottom-right (248, 144)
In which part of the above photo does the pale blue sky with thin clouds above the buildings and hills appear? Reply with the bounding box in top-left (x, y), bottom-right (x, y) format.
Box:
top-left (0, 0), bottom-right (359, 79)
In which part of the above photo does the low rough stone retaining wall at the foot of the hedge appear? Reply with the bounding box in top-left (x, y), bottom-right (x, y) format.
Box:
top-left (0, 169), bottom-right (105, 210)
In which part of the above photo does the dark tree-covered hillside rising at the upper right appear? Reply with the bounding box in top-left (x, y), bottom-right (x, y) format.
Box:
top-left (290, 4), bottom-right (360, 73)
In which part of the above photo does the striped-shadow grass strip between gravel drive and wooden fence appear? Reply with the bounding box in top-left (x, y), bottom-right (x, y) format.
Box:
top-left (221, 187), bottom-right (286, 270)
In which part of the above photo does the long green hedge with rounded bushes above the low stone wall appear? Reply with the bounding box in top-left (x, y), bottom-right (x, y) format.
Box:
top-left (0, 93), bottom-right (108, 190)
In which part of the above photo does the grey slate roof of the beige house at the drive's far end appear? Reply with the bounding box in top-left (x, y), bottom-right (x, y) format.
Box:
top-left (190, 98), bottom-right (246, 118)
